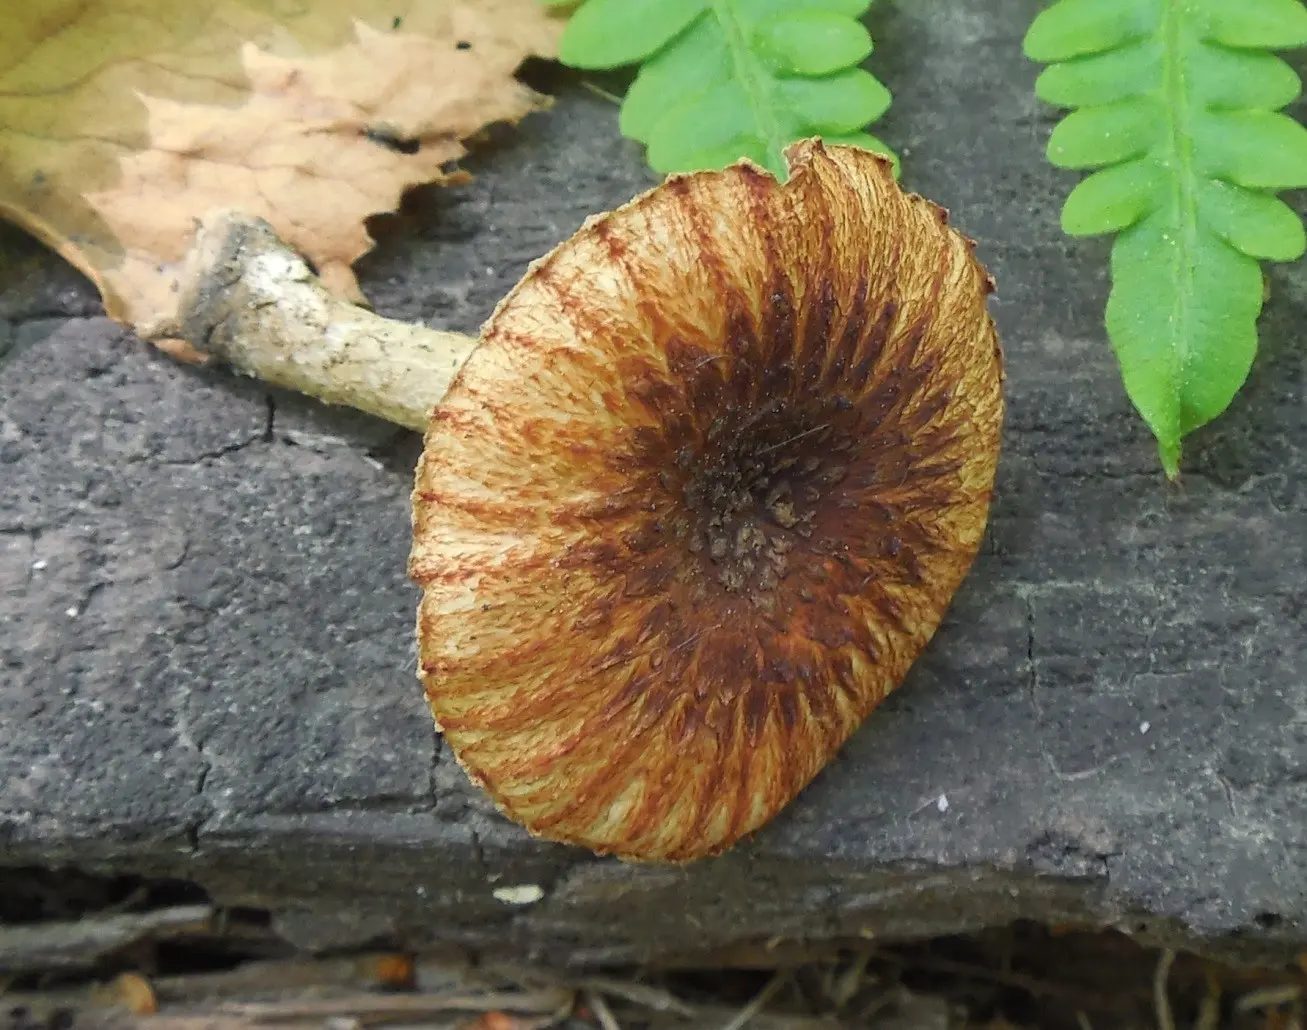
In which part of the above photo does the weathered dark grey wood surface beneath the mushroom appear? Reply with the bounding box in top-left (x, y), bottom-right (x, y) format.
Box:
top-left (0, 0), bottom-right (1307, 962)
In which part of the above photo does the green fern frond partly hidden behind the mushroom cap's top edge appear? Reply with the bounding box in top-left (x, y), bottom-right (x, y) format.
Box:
top-left (546, 0), bottom-right (898, 178)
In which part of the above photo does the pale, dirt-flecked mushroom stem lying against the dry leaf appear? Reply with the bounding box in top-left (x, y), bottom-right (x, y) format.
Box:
top-left (171, 210), bottom-right (477, 433)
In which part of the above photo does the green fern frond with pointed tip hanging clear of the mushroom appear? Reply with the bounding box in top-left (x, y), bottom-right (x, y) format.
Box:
top-left (1025, 0), bottom-right (1307, 478)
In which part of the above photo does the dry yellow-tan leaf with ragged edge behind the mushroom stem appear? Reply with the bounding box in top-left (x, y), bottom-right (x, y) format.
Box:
top-left (0, 0), bottom-right (561, 345)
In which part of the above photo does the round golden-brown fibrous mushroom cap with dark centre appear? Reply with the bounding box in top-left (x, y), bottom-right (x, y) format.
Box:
top-left (409, 140), bottom-right (1002, 861)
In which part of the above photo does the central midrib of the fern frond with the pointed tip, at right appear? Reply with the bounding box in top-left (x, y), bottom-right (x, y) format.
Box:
top-left (1162, 0), bottom-right (1199, 413)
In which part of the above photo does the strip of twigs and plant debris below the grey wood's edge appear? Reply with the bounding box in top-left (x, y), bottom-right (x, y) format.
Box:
top-left (0, 911), bottom-right (1307, 1030)
